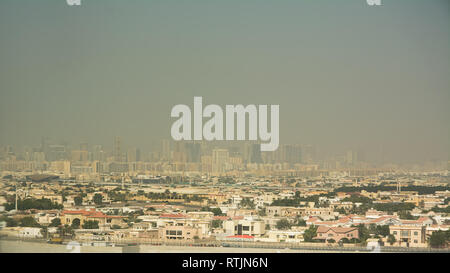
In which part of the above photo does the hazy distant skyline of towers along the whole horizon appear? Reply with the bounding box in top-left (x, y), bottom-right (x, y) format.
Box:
top-left (0, 136), bottom-right (450, 169)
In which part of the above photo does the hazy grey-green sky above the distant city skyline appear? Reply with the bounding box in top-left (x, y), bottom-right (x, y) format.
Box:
top-left (0, 0), bottom-right (450, 161)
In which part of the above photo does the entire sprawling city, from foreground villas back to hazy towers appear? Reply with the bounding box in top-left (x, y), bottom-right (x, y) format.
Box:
top-left (0, 137), bottom-right (450, 251)
